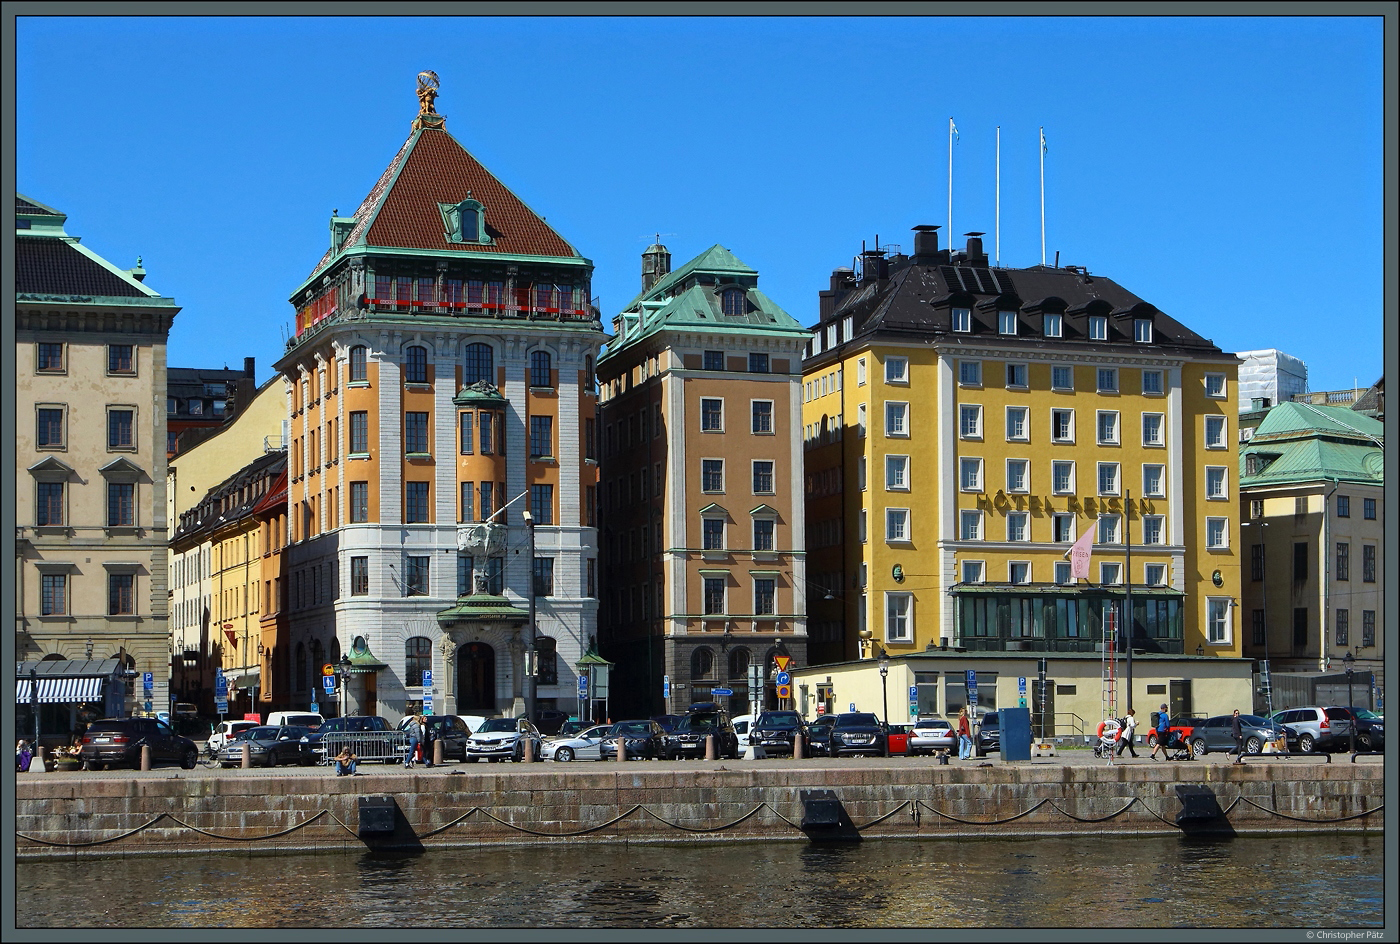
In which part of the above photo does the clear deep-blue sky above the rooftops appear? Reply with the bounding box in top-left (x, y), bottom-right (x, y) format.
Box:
top-left (15, 17), bottom-right (1383, 389)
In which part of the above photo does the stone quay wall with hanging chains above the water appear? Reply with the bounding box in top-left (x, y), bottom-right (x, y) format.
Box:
top-left (15, 756), bottom-right (1385, 860)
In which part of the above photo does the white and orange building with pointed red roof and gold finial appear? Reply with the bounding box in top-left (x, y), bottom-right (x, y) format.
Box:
top-left (277, 73), bottom-right (605, 720)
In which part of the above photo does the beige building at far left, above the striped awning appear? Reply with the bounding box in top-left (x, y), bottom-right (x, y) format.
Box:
top-left (13, 190), bottom-right (179, 733)
